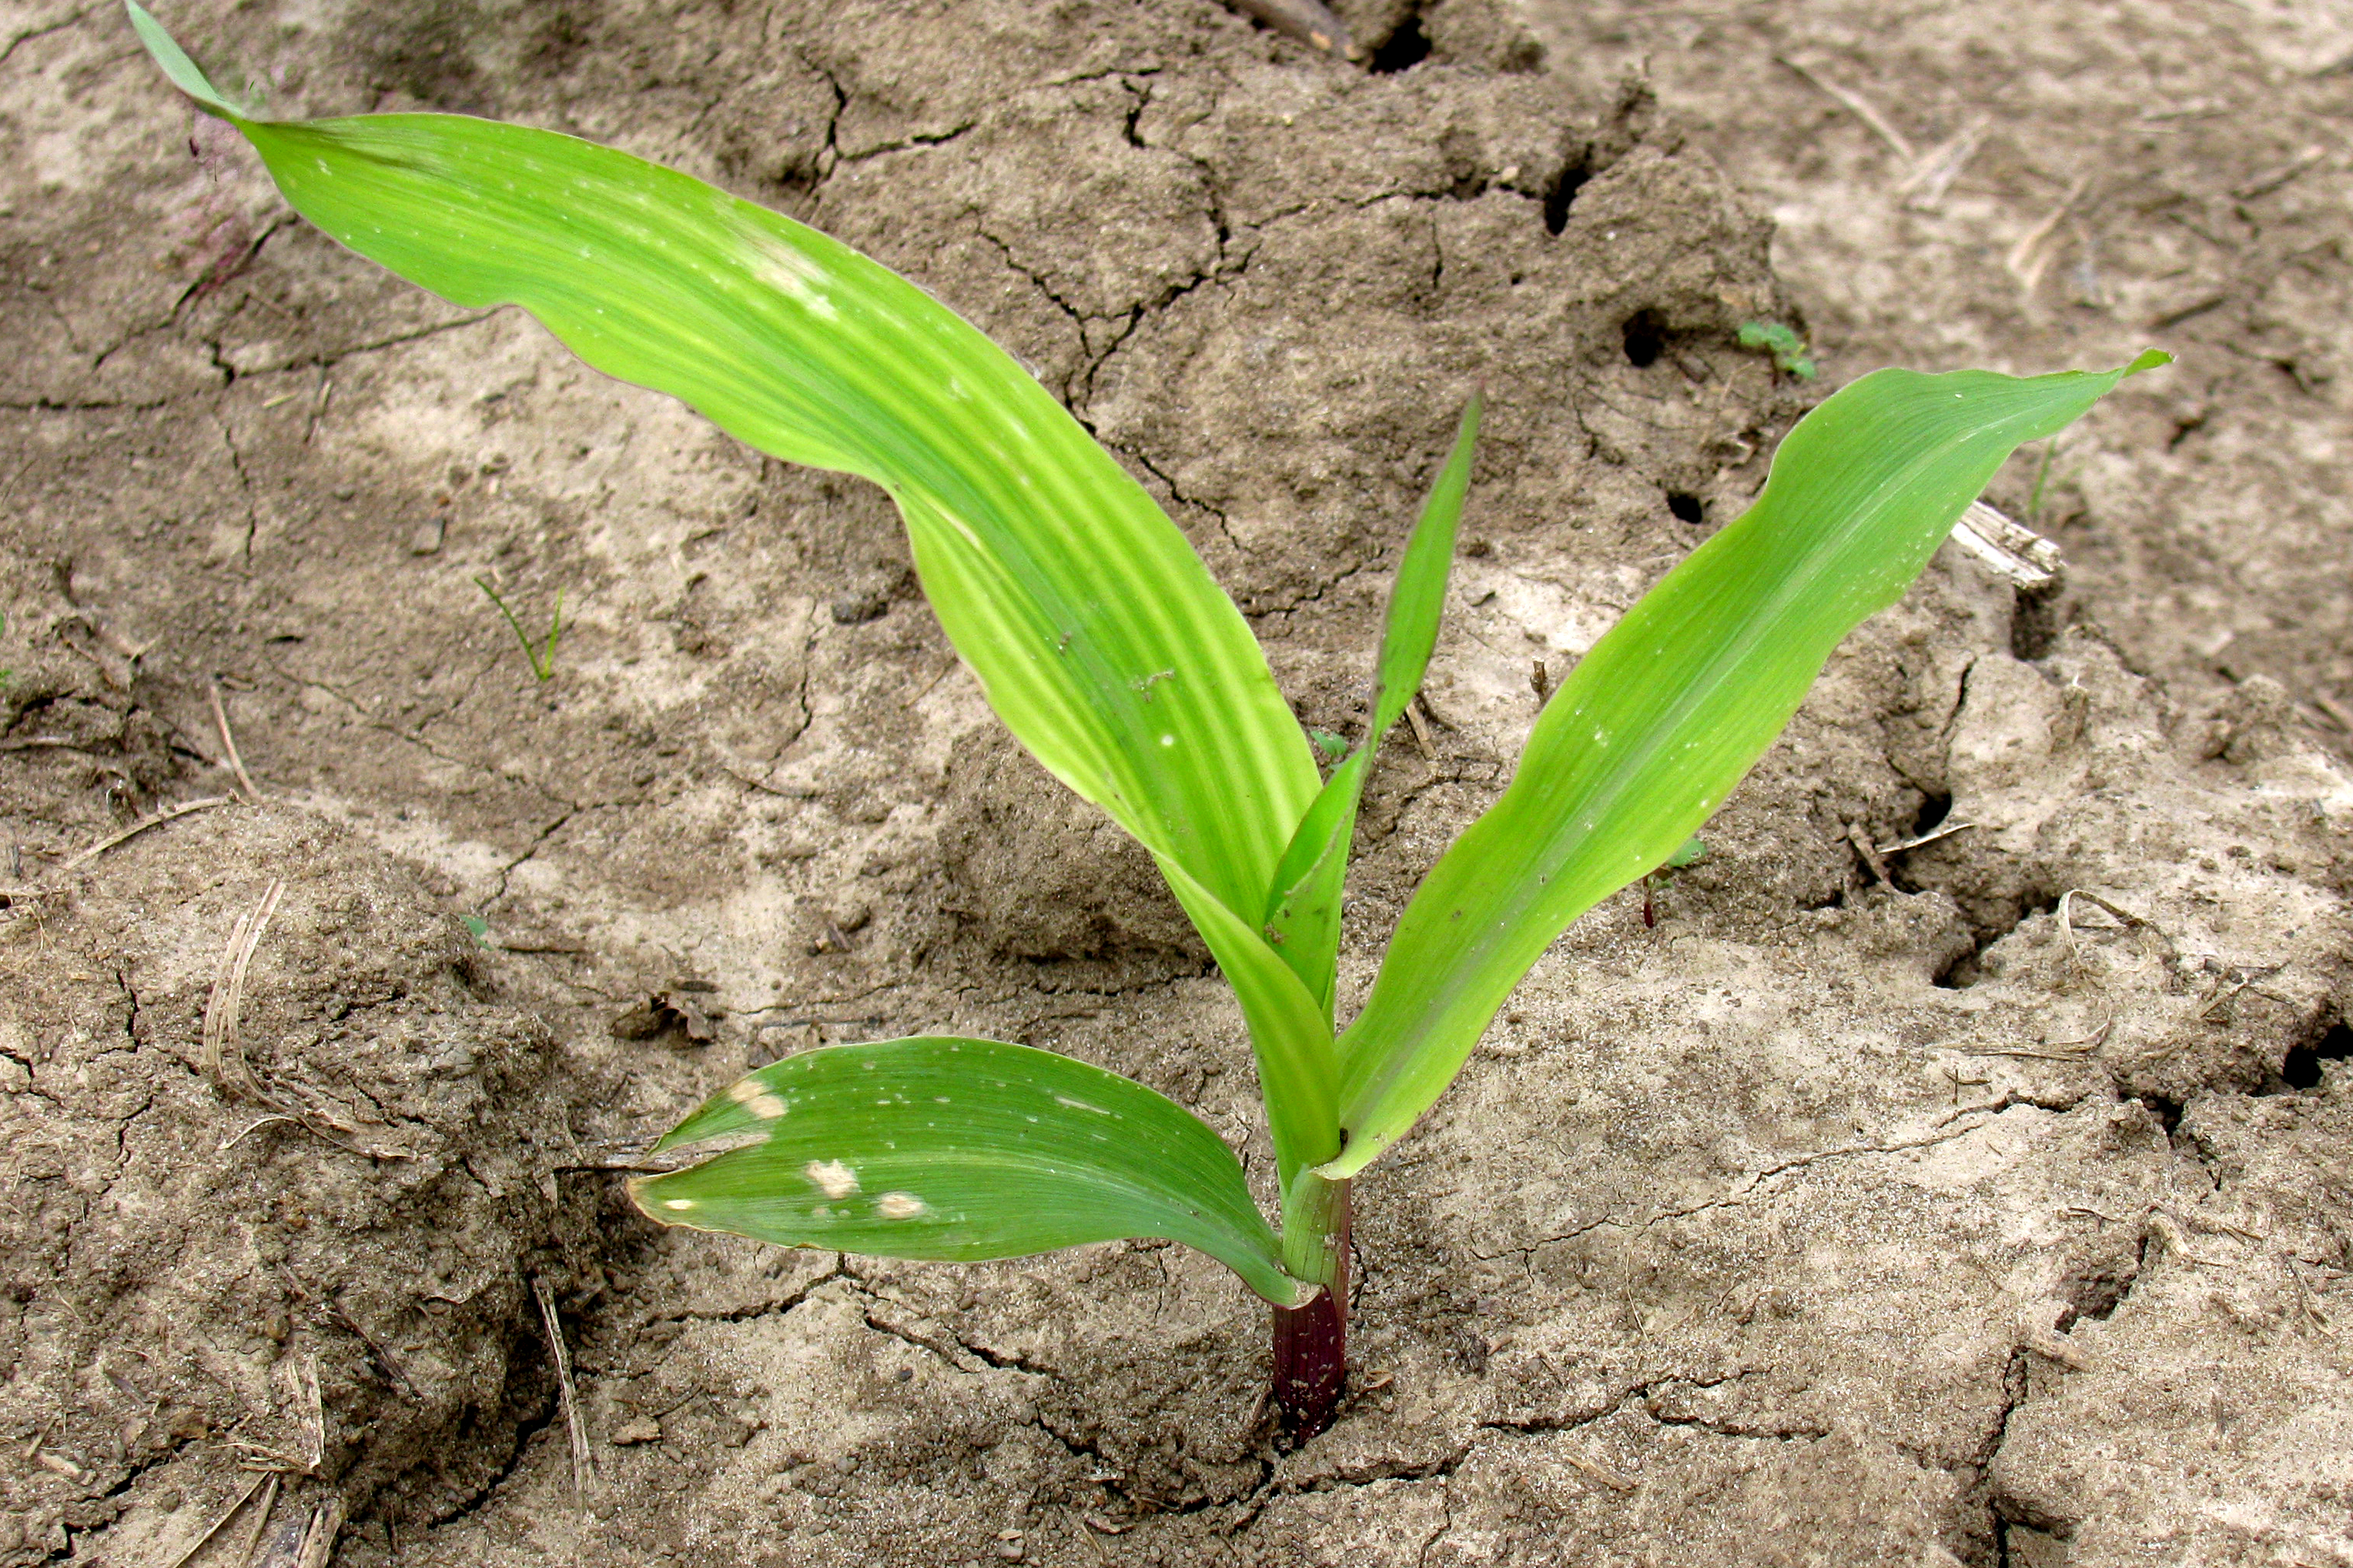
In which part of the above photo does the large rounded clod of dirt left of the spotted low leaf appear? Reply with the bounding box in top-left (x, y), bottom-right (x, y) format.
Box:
top-left (0, 807), bottom-right (564, 1563)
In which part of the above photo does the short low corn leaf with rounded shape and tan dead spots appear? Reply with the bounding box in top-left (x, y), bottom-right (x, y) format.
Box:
top-left (628, 1035), bottom-right (1315, 1307)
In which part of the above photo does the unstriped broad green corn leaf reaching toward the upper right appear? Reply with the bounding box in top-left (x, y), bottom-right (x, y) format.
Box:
top-left (1320, 353), bottom-right (2167, 1178)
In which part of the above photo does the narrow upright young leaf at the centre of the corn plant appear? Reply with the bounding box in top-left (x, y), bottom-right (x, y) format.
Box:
top-left (1266, 393), bottom-right (1480, 1022)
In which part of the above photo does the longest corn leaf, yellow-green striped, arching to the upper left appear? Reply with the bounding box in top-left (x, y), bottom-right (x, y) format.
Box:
top-left (132, 5), bottom-right (1339, 1164)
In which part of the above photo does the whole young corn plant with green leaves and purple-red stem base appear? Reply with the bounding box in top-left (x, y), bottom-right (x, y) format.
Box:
top-left (129, 0), bottom-right (2162, 1434)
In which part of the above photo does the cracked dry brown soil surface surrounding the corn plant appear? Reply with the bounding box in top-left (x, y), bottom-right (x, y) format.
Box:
top-left (0, 0), bottom-right (2353, 1568)
